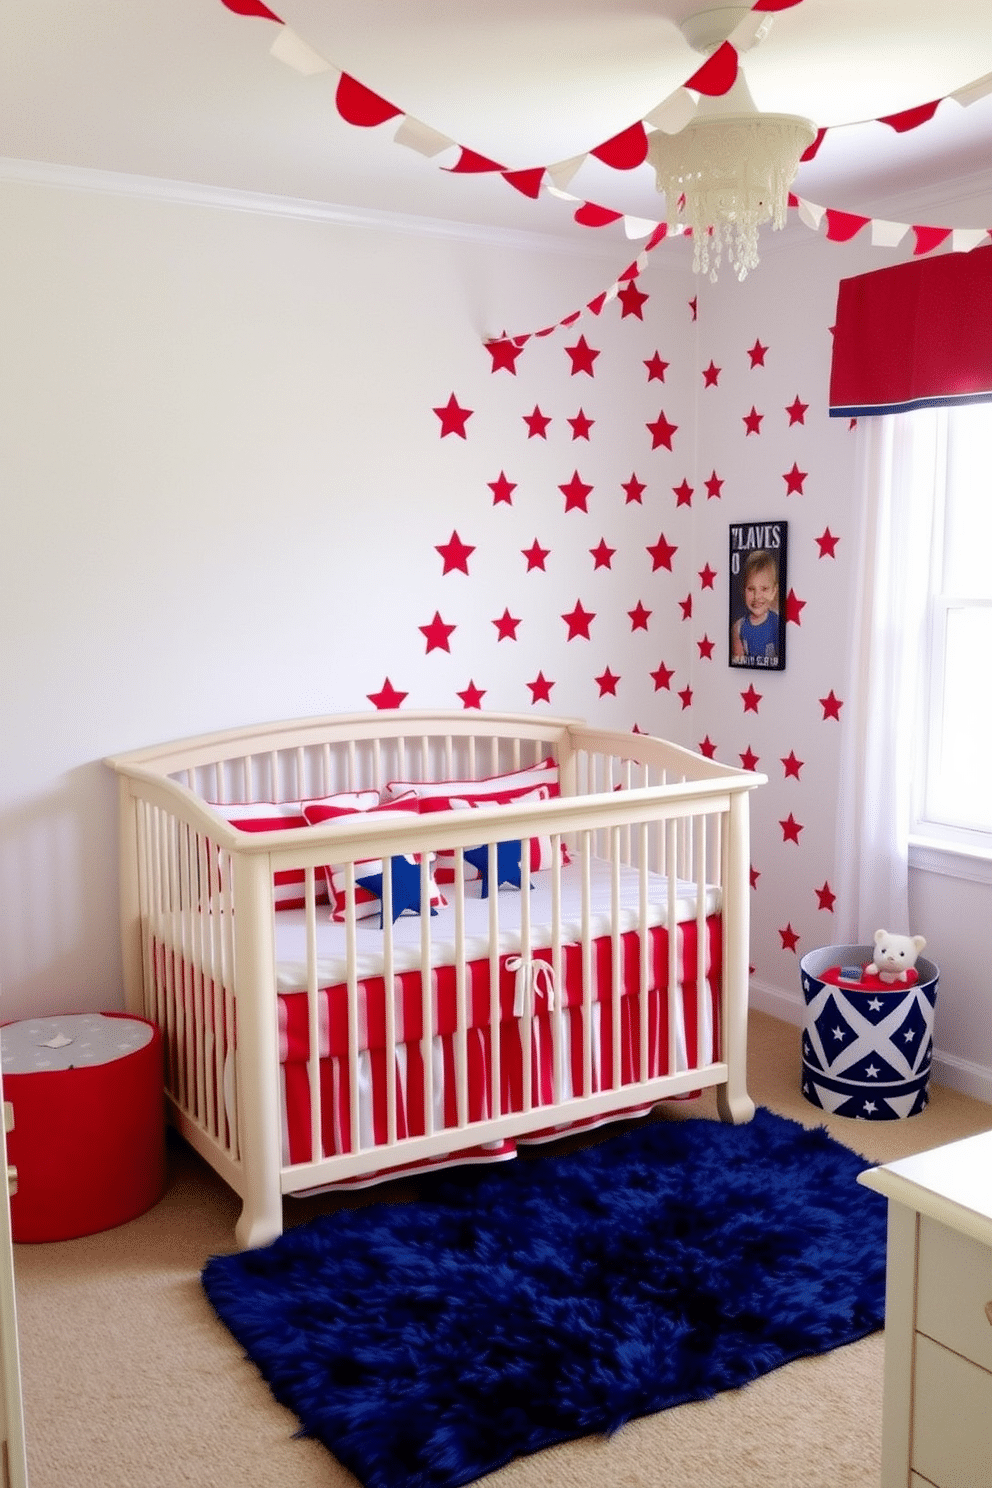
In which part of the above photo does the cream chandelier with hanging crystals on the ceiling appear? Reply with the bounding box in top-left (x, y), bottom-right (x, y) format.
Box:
top-left (648, 18), bottom-right (817, 281)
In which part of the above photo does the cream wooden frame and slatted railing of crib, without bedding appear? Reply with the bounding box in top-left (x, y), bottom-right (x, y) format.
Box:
top-left (107, 717), bottom-right (760, 1244)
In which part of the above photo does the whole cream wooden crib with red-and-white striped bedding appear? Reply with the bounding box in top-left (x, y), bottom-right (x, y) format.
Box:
top-left (107, 711), bottom-right (764, 1247)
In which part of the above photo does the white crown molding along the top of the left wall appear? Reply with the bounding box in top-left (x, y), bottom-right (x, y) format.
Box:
top-left (0, 156), bottom-right (627, 263)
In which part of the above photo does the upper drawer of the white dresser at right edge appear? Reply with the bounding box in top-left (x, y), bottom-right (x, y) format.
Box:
top-left (916, 1216), bottom-right (992, 1369)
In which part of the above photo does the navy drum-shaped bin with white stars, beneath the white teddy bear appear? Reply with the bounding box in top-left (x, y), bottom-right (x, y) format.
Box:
top-left (799, 945), bottom-right (940, 1120)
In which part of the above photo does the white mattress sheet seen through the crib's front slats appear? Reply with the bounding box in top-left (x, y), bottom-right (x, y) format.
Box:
top-left (275, 859), bottom-right (721, 992)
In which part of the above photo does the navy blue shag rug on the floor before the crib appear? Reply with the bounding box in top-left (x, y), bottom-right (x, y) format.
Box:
top-left (202, 1110), bottom-right (886, 1488)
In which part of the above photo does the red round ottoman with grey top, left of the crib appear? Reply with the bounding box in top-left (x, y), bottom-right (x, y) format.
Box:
top-left (0, 1013), bottom-right (165, 1241)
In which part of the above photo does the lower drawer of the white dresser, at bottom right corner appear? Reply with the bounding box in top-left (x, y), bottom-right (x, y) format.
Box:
top-left (912, 1336), bottom-right (992, 1488)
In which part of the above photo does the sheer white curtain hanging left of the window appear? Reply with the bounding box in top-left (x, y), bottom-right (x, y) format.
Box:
top-left (836, 409), bottom-right (947, 945)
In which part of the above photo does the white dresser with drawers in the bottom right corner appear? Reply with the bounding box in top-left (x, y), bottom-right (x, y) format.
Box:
top-left (860, 1131), bottom-right (992, 1488)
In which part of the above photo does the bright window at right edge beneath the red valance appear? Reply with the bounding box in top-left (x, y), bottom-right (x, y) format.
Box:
top-left (913, 403), bottom-right (992, 856)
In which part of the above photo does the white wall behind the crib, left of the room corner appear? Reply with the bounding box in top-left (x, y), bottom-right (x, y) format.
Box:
top-left (0, 171), bottom-right (687, 1018)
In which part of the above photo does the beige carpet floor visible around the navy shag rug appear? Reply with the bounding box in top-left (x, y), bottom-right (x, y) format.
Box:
top-left (15, 1013), bottom-right (992, 1488)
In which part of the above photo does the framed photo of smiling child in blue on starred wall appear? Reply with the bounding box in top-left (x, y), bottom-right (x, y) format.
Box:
top-left (729, 522), bottom-right (788, 671)
